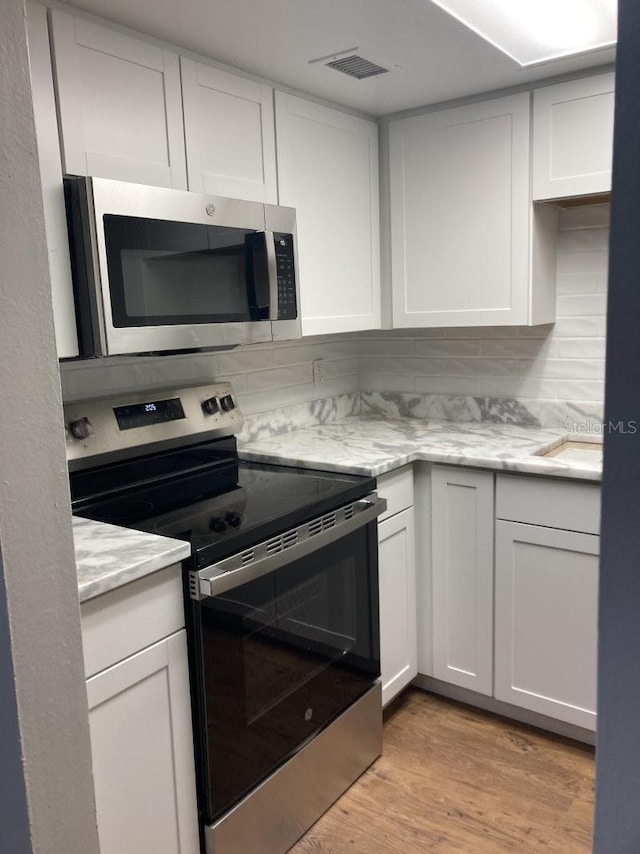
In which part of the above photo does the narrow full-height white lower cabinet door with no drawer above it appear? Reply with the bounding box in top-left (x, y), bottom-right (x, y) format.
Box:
top-left (431, 466), bottom-right (494, 696)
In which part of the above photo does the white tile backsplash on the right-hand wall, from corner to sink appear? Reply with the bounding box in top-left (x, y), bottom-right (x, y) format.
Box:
top-left (360, 205), bottom-right (609, 406)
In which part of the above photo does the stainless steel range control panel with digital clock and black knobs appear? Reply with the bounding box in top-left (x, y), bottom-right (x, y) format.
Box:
top-left (64, 383), bottom-right (243, 469)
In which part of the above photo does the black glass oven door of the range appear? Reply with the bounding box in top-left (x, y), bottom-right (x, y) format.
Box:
top-left (192, 499), bottom-right (385, 824)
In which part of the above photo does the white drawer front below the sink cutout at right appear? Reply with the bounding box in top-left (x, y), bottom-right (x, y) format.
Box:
top-left (496, 475), bottom-right (600, 534)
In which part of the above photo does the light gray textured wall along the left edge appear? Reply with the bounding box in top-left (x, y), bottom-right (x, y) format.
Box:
top-left (0, 0), bottom-right (98, 854)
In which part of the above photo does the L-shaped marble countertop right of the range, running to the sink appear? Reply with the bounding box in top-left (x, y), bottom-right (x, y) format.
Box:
top-left (239, 416), bottom-right (602, 482)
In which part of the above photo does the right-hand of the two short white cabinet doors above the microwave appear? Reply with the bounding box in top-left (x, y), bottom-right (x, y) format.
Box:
top-left (180, 56), bottom-right (278, 204)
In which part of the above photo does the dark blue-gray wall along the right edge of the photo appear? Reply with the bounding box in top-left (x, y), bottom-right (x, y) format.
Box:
top-left (594, 0), bottom-right (640, 854)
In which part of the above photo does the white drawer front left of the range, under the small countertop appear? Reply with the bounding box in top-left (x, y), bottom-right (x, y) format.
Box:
top-left (80, 564), bottom-right (184, 678)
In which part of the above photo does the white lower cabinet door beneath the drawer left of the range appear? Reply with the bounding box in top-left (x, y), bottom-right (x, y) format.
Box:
top-left (87, 630), bottom-right (200, 854)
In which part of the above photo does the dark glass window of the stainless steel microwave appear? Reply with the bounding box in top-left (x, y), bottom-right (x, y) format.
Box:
top-left (104, 214), bottom-right (268, 327)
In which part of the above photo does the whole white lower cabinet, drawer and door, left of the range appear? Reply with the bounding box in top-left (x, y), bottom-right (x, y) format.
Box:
top-left (81, 566), bottom-right (200, 854)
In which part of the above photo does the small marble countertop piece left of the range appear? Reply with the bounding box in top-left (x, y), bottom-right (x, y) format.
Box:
top-left (73, 516), bottom-right (191, 602)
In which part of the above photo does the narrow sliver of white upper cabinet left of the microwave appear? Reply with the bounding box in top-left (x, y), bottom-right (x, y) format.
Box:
top-left (27, 3), bottom-right (79, 359)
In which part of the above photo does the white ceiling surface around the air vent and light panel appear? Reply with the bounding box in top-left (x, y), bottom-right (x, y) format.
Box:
top-left (63, 0), bottom-right (615, 116)
